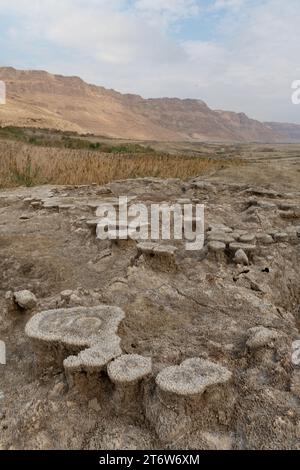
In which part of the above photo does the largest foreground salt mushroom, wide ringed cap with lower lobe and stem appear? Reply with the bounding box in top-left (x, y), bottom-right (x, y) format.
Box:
top-left (25, 306), bottom-right (125, 372)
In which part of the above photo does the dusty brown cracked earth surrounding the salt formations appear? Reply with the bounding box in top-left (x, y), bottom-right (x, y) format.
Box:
top-left (0, 144), bottom-right (300, 449)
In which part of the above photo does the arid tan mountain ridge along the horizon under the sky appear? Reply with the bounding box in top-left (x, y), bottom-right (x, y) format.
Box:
top-left (0, 67), bottom-right (300, 142)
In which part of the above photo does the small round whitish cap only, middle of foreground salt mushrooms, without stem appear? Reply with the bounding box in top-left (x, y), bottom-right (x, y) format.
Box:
top-left (107, 354), bottom-right (152, 385)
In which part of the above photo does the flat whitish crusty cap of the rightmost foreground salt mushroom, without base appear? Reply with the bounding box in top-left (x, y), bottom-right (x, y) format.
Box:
top-left (156, 358), bottom-right (232, 396)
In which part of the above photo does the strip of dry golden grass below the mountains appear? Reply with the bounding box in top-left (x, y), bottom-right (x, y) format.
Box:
top-left (0, 141), bottom-right (240, 188)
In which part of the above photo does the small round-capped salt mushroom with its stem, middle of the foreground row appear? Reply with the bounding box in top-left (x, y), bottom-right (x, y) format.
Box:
top-left (107, 354), bottom-right (152, 414)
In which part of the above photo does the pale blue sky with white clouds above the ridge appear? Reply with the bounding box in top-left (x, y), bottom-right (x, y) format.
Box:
top-left (0, 0), bottom-right (300, 124)
